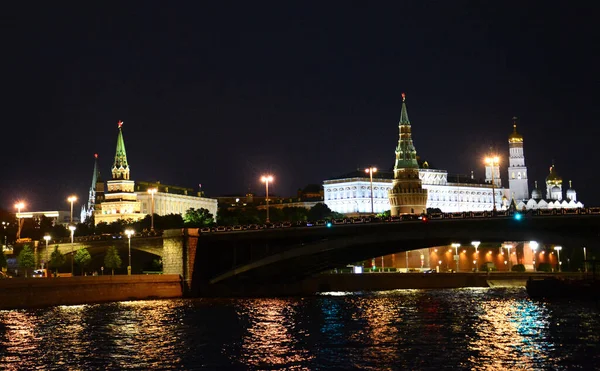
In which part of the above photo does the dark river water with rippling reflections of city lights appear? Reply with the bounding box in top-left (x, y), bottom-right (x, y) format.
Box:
top-left (0, 288), bottom-right (600, 370)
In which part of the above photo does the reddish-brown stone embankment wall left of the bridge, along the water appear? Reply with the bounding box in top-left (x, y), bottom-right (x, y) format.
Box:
top-left (0, 274), bottom-right (183, 309)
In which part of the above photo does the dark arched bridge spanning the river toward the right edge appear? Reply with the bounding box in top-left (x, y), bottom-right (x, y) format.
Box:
top-left (187, 215), bottom-right (600, 293)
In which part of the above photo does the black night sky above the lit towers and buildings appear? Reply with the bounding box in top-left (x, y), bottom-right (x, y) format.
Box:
top-left (0, 0), bottom-right (600, 210)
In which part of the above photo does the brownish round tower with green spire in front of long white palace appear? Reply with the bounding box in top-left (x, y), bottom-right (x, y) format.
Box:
top-left (389, 93), bottom-right (427, 216)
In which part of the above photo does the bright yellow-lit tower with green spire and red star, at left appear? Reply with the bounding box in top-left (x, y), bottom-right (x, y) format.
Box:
top-left (94, 121), bottom-right (146, 225)
